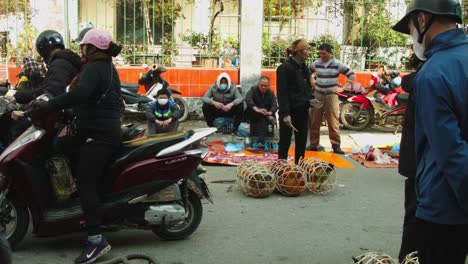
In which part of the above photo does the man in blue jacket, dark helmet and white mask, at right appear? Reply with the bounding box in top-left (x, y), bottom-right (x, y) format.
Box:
top-left (393, 0), bottom-right (468, 264)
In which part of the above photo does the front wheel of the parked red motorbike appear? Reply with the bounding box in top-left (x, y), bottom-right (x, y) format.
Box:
top-left (340, 103), bottom-right (372, 131)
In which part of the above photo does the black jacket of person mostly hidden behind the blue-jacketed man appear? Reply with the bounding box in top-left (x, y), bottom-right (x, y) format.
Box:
top-left (398, 72), bottom-right (416, 179)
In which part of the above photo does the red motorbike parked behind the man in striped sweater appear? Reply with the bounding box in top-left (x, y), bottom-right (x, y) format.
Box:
top-left (340, 72), bottom-right (406, 131)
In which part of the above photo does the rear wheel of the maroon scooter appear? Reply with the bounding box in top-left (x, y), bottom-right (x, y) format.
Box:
top-left (153, 190), bottom-right (203, 240)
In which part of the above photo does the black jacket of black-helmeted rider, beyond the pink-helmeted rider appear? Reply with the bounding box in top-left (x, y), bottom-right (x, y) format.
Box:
top-left (15, 49), bottom-right (82, 104)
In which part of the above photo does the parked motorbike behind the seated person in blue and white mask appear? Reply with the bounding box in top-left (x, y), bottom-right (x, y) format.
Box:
top-left (121, 64), bottom-right (189, 122)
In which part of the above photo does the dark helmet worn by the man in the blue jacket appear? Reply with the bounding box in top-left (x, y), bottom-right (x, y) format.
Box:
top-left (393, 0), bottom-right (463, 35)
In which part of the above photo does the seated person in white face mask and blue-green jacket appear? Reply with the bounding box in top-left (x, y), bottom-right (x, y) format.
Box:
top-left (146, 88), bottom-right (182, 135)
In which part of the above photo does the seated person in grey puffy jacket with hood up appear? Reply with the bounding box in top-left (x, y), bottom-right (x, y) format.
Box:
top-left (202, 72), bottom-right (244, 132)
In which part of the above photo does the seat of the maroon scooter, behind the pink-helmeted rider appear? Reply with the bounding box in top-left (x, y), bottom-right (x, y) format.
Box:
top-left (110, 130), bottom-right (193, 171)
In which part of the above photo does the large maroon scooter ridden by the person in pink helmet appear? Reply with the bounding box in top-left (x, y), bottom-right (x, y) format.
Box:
top-left (0, 96), bottom-right (216, 248)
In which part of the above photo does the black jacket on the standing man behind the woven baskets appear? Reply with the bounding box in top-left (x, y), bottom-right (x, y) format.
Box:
top-left (276, 57), bottom-right (313, 118)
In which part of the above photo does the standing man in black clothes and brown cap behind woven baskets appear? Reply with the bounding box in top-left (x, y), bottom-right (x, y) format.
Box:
top-left (276, 39), bottom-right (312, 164)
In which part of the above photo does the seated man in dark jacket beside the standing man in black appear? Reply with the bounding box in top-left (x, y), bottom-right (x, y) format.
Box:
top-left (245, 76), bottom-right (278, 148)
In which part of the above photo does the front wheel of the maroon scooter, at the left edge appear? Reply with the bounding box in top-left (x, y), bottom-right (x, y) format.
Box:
top-left (0, 199), bottom-right (29, 250)
